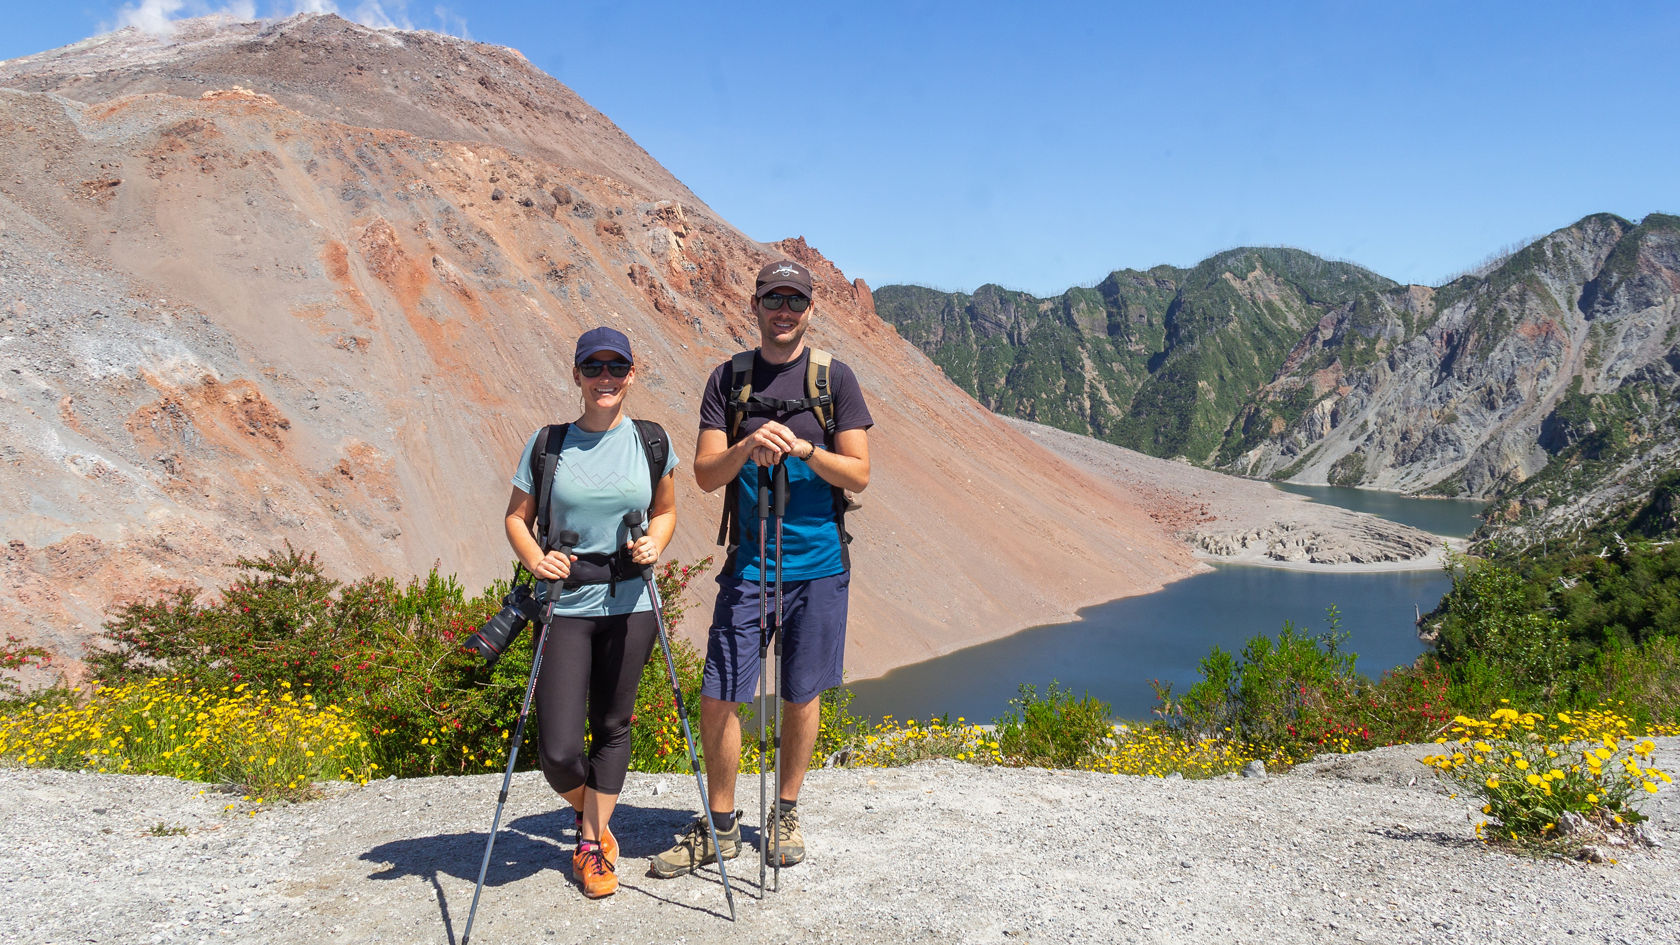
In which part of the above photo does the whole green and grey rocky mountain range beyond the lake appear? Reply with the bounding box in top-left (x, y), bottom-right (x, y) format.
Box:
top-left (875, 214), bottom-right (1680, 543)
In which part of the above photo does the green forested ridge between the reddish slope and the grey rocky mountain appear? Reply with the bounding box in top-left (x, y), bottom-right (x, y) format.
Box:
top-left (875, 249), bottom-right (1394, 462)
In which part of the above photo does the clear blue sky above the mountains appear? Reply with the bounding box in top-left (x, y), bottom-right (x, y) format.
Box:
top-left (0, 0), bottom-right (1680, 294)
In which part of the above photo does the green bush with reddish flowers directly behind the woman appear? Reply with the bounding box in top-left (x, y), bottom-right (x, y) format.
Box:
top-left (77, 545), bottom-right (711, 777)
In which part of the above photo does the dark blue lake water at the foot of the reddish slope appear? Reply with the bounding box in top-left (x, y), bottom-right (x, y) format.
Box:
top-left (850, 486), bottom-right (1480, 721)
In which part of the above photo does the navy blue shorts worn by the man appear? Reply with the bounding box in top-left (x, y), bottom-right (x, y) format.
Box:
top-left (701, 572), bottom-right (852, 703)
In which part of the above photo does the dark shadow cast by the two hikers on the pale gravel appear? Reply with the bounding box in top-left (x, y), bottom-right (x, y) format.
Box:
top-left (360, 802), bottom-right (746, 945)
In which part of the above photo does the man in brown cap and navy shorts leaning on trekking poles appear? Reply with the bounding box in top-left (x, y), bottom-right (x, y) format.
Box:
top-left (648, 259), bottom-right (874, 878)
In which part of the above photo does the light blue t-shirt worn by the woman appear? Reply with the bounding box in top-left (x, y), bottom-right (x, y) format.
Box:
top-left (512, 417), bottom-right (677, 617)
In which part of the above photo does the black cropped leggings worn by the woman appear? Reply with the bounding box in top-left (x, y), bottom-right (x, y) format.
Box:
top-left (536, 610), bottom-right (659, 794)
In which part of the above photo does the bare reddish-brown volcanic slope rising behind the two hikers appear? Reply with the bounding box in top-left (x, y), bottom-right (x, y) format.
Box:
top-left (0, 17), bottom-right (1194, 674)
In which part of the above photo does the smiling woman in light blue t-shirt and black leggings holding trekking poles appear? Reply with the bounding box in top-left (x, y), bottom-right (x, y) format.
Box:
top-left (507, 328), bottom-right (677, 900)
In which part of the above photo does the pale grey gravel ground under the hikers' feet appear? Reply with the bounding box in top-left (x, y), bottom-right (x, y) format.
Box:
top-left (0, 738), bottom-right (1680, 945)
